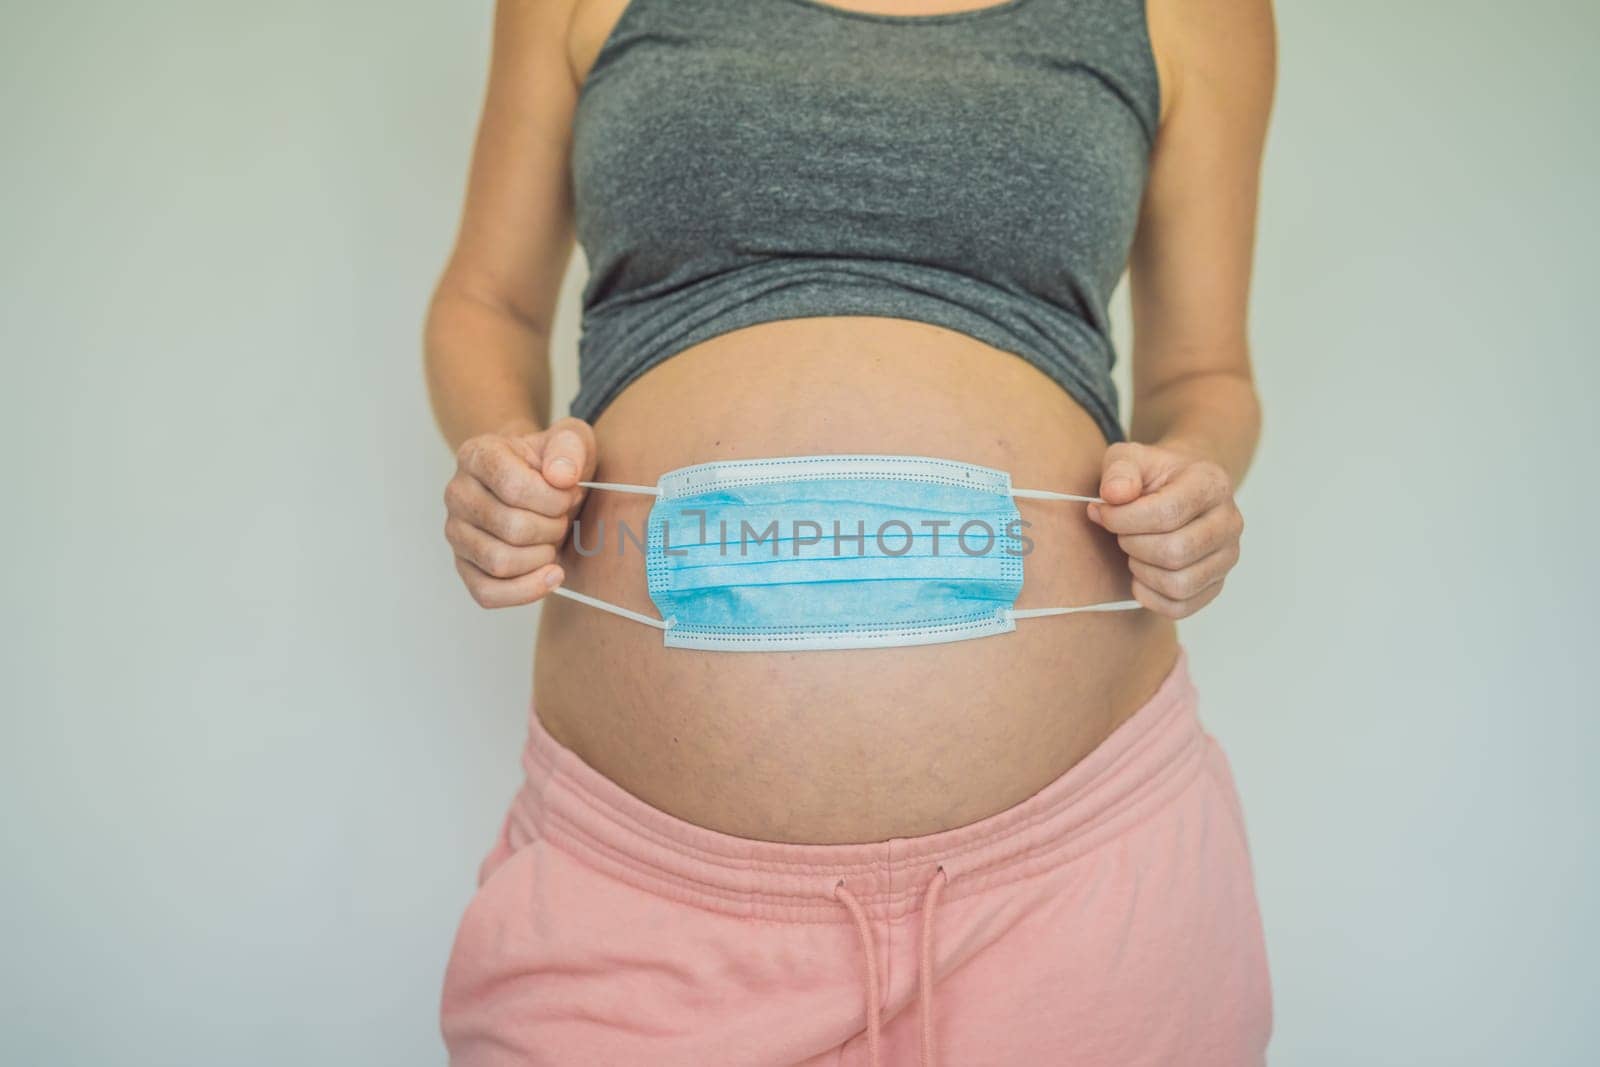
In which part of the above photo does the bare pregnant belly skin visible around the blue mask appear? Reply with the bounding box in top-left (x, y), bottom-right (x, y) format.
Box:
top-left (534, 318), bottom-right (1178, 843)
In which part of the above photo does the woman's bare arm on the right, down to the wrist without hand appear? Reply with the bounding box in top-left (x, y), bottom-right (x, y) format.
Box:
top-left (1130, 0), bottom-right (1277, 485)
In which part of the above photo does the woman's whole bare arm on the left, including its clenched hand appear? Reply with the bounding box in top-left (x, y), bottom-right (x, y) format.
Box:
top-left (424, 0), bottom-right (595, 608)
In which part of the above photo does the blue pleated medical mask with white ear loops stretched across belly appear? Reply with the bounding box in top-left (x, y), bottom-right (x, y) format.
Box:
top-left (554, 456), bottom-right (1141, 651)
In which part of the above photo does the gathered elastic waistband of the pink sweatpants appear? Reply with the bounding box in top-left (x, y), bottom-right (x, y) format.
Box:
top-left (507, 645), bottom-right (1206, 923)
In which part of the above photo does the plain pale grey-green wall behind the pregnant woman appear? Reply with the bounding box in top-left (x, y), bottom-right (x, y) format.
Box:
top-left (0, 0), bottom-right (1600, 1067)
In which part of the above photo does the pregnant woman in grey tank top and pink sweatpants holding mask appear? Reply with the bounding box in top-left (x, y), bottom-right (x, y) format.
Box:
top-left (426, 0), bottom-right (1275, 1067)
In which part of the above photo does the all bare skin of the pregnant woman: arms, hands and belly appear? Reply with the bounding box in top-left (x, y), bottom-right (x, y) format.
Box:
top-left (426, 0), bottom-right (1275, 843)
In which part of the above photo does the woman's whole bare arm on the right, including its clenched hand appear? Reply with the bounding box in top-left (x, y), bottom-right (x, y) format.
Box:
top-left (1088, 0), bottom-right (1277, 617)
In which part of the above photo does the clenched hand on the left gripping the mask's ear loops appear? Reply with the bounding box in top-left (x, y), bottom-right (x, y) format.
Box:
top-left (445, 418), bottom-right (595, 608)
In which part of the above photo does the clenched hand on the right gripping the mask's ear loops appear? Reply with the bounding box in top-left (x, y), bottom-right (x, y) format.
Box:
top-left (1088, 442), bottom-right (1245, 619)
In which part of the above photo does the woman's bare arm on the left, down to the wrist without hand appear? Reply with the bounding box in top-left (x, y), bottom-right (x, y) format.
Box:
top-left (424, 0), bottom-right (578, 448)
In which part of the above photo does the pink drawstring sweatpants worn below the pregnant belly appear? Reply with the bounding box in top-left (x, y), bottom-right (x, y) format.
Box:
top-left (442, 649), bottom-right (1272, 1067)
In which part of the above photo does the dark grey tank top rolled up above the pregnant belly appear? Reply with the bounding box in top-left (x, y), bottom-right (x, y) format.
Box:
top-left (571, 0), bottom-right (1158, 442)
